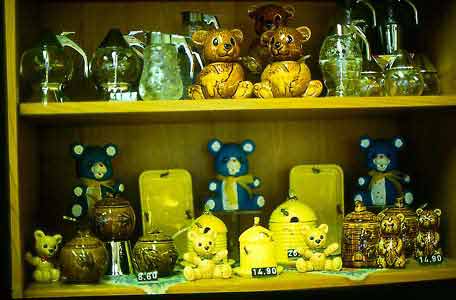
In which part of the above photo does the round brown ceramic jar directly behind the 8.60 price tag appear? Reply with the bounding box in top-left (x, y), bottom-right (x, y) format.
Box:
top-left (133, 230), bottom-right (177, 277)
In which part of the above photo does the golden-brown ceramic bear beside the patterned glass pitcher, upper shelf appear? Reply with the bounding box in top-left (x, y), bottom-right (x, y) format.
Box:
top-left (188, 29), bottom-right (253, 99)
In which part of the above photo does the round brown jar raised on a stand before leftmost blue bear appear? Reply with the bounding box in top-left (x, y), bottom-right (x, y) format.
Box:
top-left (95, 196), bottom-right (136, 241)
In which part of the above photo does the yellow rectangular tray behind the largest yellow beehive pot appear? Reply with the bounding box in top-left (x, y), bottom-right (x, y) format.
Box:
top-left (290, 165), bottom-right (344, 253)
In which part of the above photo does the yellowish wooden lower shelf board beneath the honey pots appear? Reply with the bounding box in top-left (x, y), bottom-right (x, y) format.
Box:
top-left (24, 259), bottom-right (456, 298)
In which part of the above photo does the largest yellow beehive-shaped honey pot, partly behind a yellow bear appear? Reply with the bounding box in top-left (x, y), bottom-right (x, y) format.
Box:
top-left (269, 195), bottom-right (317, 267)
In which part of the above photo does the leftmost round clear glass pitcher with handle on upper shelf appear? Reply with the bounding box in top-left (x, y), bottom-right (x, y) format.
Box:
top-left (19, 31), bottom-right (88, 105)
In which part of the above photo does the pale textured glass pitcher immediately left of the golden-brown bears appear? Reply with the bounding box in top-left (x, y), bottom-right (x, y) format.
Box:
top-left (139, 32), bottom-right (195, 100)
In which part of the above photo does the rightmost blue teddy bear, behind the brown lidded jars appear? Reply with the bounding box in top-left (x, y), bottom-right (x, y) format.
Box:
top-left (354, 136), bottom-right (413, 207)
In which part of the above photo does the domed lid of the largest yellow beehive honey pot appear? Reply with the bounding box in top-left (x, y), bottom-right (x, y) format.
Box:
top-left (269, 195), bottom-right (317, 224)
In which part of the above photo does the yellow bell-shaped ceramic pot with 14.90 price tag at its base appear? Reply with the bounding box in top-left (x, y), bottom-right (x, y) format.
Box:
top-left (234, 217), bottom-right (283, 277)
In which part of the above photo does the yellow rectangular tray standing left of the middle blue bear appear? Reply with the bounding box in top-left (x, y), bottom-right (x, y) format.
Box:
top-left (139, 169), bottom-right (194, 254)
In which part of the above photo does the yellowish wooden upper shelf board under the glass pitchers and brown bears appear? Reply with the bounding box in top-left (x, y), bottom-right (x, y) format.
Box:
top-left (19, 95), bottom-right (456, 123)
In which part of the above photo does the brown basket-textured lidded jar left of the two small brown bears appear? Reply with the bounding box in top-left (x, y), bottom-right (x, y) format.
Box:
top-left (342, 201), bottom-right (379, 268)
